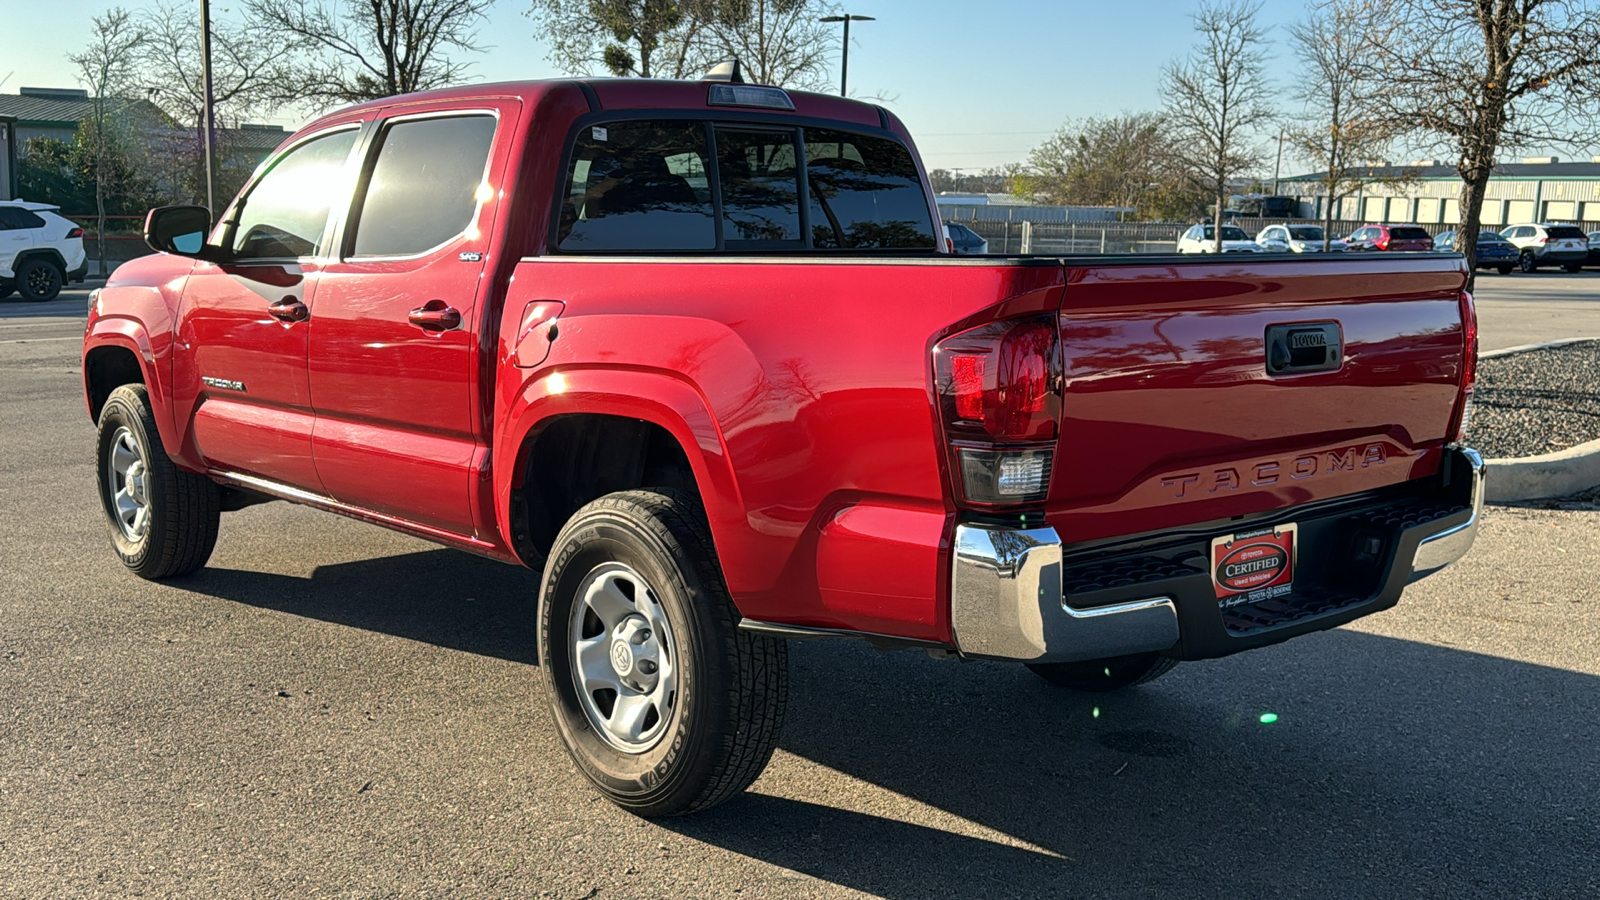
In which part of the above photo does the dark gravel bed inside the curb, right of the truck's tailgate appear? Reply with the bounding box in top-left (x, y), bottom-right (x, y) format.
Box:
top-left (1467, 341), bottom-right (1600, 460)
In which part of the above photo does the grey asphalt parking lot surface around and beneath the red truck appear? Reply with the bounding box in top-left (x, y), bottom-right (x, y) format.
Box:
top-left (0, 274), bottom-right (1600, 900)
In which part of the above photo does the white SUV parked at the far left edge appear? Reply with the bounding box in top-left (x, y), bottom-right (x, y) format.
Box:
top-left (0, 200), bottom-right (90, 301)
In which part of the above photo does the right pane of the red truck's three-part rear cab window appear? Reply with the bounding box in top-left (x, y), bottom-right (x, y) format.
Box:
top-left (805, 128), bottom-right (936, 250)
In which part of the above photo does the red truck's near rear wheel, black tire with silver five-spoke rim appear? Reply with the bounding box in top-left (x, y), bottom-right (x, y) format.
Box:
top-left (539, 490), bottom-right (789, 817)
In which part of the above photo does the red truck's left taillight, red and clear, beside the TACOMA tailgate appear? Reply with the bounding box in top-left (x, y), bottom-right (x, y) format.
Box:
top-left (934, 317), bottom-right (1061, 506)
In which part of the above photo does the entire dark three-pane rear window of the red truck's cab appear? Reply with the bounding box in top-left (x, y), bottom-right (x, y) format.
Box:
top-left (555, 119), bottom-right (938, 253)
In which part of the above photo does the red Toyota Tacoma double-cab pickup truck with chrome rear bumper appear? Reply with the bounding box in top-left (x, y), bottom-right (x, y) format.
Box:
top-left (83, 80), bottom-right (1483, 815)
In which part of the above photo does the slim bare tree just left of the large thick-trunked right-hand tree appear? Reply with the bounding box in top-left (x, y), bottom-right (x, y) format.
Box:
top-left (1288, 0), bottom-right (1414, 251)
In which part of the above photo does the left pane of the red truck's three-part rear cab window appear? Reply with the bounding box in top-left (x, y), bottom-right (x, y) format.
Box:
top-left (557, 122), bottom-right (717, 253)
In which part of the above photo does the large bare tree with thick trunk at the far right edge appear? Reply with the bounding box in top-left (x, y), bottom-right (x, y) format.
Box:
top-left (1363, 0), bottom-right (1600, 277)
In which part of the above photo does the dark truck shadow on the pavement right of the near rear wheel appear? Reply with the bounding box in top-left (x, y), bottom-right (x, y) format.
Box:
top-left (662, 629), bottom-right (1600, 898)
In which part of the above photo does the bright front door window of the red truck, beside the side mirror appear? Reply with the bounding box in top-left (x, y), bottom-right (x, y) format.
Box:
top-left (229, 128), bottom-right (355, 259)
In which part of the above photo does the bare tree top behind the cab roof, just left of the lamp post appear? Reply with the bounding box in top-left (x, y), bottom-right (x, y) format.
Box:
top-left (694, 0), bottom-right (832, 91)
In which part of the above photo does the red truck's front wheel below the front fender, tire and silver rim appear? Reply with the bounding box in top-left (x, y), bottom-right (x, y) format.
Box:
top-left (94, 384), bottom-right (222, 580)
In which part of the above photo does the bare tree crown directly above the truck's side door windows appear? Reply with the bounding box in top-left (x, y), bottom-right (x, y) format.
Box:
top-left (246, 0), bottom-right (494, 104)
